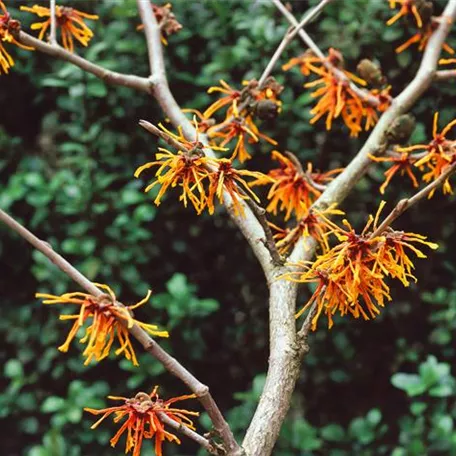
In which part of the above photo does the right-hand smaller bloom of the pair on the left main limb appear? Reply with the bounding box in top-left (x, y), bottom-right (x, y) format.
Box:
top-left (207, 158), bottom-right (266, 215)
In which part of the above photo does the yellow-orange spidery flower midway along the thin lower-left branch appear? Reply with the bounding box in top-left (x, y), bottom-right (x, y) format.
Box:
top-left (36, 283), bottom-right (168, 366)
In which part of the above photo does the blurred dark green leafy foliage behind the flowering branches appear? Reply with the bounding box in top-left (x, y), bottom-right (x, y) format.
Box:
top-left (0, 0), bottom-right (456, 456)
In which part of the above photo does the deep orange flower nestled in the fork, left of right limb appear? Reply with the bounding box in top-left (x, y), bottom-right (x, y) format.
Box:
top-left (250, 150), bottom-right (340, 220)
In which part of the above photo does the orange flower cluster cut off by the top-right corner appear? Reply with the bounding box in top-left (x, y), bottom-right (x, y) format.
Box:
top-left (386, 0), bottom-right (454, 54)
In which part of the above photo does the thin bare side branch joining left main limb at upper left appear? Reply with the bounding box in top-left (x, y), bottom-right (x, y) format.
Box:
top-left (15, 31), bottom-right (153, 94)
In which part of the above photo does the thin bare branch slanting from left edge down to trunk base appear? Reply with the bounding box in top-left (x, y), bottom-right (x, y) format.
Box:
top-left (0, 209), bottom-right (237, 456)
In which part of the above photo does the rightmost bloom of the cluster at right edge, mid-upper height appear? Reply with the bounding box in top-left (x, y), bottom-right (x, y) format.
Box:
top-left (397, 112), bottom-right (456, 198)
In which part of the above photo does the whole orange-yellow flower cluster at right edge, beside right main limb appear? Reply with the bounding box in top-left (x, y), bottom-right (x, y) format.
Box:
top-left (371, 112), bottom-right (456, 198)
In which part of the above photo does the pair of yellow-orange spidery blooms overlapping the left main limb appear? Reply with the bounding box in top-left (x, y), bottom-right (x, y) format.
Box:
top-left (135, 124), bottom-right (265, 215)
